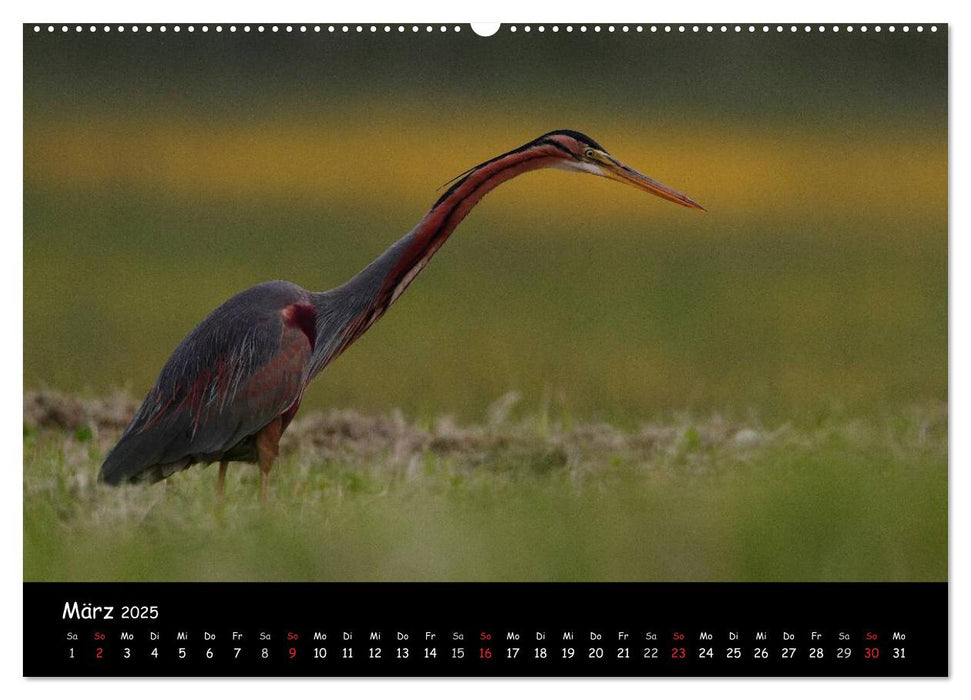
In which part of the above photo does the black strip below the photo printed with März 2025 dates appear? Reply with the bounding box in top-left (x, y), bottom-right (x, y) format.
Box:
top-left (24, 583), bottom-right (949, 678)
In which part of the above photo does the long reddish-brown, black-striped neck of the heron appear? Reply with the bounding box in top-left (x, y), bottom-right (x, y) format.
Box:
top-left (316, 143), bottom-right (562, 371)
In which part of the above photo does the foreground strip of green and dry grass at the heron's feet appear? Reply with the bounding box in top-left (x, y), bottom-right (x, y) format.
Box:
top-left (24, 400), bottom-right (947, 581)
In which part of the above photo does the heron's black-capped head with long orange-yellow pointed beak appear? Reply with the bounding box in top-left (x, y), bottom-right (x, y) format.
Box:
top-left (536, 129), bottom-right (706, 211)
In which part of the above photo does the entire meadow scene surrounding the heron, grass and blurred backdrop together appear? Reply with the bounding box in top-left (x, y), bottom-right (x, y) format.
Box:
top-left (23, 31), bottom-right (948, 581)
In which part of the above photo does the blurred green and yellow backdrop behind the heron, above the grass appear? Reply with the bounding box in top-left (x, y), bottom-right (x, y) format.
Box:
top-left (24, 30), bottom-right (947, 420)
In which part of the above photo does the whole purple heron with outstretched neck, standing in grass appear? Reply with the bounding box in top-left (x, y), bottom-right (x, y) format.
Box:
top-left (99, 130), bottom-right (702, 499)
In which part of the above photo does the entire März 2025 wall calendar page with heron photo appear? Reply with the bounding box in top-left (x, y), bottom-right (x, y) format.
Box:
top-left (22, 21), bottom-right (949, 678)
